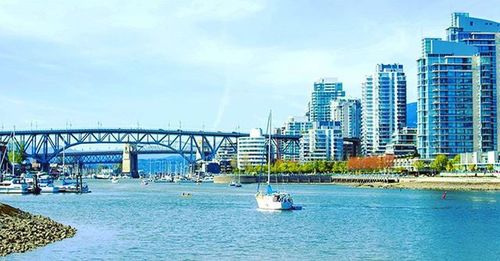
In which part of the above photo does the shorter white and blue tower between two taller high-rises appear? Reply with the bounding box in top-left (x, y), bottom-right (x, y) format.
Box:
top-left (330, 99), bottom-right (361, 138)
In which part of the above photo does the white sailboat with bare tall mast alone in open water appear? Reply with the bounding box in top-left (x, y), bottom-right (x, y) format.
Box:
top-left (255, 109), bottom-right (294, 210)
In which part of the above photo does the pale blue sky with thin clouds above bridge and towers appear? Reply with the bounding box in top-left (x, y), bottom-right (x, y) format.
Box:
top-left (0, 0), bottom-right (500, 132)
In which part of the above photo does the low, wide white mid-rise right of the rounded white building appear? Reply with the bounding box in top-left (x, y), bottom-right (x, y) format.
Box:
top-left (300, 121), bottom-right (343, 162)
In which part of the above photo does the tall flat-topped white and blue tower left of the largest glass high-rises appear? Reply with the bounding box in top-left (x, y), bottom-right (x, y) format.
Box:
top-left (361, 64), bottom-right (406, 155)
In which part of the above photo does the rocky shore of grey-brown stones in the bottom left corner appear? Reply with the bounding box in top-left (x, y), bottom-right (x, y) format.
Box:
top-left (0, 203), bottom-right (76, 256)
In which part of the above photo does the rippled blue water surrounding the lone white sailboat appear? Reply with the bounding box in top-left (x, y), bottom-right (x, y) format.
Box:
top-left (0, 180), bottom-right (500, 260)
